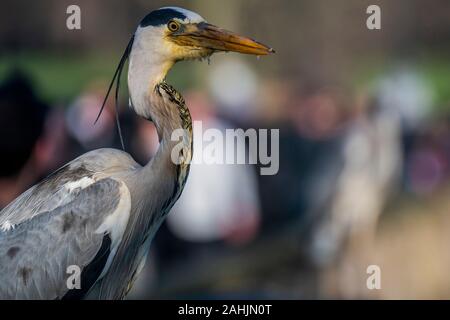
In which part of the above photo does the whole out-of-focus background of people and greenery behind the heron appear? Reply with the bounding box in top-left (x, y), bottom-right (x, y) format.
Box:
top-left (0, 0), bottom-right (450, 299)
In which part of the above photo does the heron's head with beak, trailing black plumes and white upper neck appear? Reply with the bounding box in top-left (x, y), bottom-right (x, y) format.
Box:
top-left (96, 7), bottom-right (275, 132)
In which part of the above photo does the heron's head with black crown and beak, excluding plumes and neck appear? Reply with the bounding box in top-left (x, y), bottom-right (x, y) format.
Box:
top-left (135, 7), bottom-right (274, 62)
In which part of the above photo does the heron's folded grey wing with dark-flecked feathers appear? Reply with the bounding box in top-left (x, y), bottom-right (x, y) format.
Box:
top-left (0, 178), bottom-right (121, 299)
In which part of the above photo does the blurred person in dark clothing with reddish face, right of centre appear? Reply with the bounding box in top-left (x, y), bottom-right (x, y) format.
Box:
top-left (253, 85), bottom-right (346, 231)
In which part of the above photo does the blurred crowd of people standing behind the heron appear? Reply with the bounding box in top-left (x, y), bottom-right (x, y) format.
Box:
top-left (0, 51), bottom-right (450, 297)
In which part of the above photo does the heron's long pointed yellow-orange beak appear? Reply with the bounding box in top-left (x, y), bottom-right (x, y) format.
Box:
top-left (172, 22), bottom-right (275, 56)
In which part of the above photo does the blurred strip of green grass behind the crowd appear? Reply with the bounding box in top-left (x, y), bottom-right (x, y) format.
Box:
top-left (0, 51), bottom-right (450, 114)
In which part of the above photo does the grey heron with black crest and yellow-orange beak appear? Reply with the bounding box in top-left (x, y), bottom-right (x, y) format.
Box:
top-left (0, 7), bottom-right (273, 299)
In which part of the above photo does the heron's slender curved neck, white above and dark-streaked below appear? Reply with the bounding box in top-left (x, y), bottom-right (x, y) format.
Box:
top-left (128, 47), bottom-right (192, 188)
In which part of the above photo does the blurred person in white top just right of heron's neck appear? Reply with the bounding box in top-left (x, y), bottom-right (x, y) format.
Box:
top-left (168, 92), bottom-right (259, 244)
